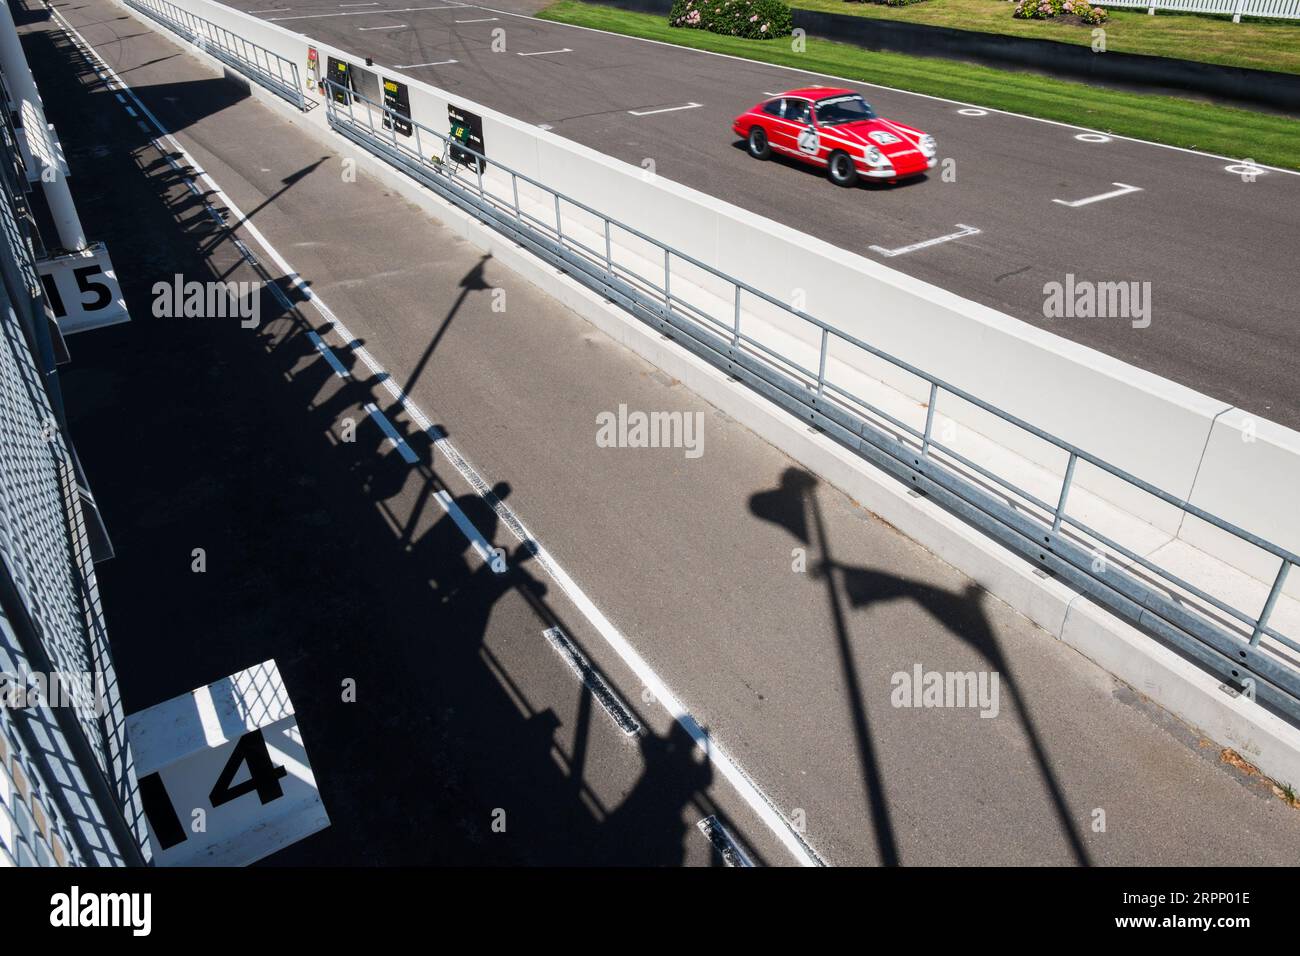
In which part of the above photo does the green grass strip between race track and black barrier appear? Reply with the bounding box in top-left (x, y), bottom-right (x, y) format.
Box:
top-left (537, 0), bottom-right (1300, 169)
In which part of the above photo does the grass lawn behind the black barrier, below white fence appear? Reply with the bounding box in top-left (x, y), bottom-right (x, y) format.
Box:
top-left (792, 0), bottom-right (1300, 73)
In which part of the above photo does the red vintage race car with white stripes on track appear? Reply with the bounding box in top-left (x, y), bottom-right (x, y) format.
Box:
top-left (732, 86), bottom-right (937, 186)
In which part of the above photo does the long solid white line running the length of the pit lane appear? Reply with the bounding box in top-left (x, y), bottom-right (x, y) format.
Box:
top-left (65, 9), bottom-right (823, 866)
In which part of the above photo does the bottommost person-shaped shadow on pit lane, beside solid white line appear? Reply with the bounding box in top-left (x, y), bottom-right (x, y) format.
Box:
top-left (601, 722), bottom-right (714, 866)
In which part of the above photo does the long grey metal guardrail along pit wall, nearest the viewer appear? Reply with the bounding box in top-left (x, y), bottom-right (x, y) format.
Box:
top-left (317, 79), bottom-right (1300, 721)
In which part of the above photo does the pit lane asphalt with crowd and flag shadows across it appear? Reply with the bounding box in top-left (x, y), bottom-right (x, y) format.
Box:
top-left (32, 0), bottom-right (1300, 865)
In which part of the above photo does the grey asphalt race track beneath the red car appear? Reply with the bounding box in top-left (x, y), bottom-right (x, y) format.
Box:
top-left (229, 0), bottom-right (1300, 428)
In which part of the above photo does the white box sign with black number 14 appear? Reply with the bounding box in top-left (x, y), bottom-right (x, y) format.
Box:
top-left (126, 661), bottom-right (329, 866)
